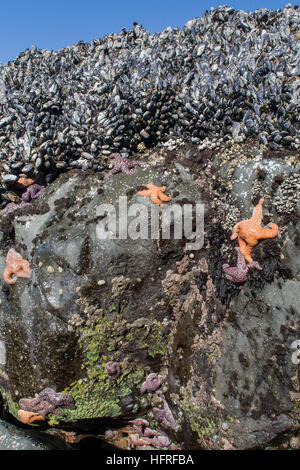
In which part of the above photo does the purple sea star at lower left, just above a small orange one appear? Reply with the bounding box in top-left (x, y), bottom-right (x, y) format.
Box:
top-left (19, 388), bottom-right (75, 416)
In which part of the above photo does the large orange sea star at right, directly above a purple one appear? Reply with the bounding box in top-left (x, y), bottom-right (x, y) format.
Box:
top-left (231, 198), bottom-right (278, 263)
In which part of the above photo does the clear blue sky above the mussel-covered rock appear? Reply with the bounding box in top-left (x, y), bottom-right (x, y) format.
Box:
top-left (0, 0), bottom-right (299, 65)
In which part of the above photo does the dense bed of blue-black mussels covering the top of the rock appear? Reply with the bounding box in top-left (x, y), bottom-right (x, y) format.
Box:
top-left (0, 4), bottom-right (300, 206)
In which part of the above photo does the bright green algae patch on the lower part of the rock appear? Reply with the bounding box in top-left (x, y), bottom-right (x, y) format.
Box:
top-left (49, 314), bottom-right (167, 425)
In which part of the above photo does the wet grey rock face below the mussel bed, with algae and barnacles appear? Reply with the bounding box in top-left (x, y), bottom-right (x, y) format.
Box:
top-left (0, 142), bottom-right (300, 449)
